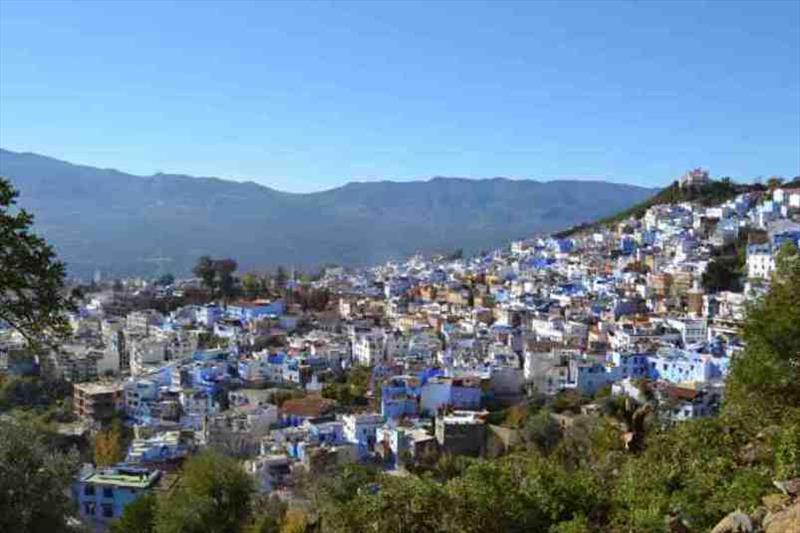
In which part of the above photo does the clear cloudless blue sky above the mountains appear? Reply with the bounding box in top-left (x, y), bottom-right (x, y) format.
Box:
top-left (0, 0), bottom-right (800, 191)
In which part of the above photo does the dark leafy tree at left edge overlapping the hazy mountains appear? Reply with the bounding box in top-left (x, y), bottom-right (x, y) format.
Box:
top-left (0, 178), bottom-right (73, 348)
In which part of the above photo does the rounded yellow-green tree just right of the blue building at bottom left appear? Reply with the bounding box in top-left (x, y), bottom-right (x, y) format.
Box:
top-left (156, 451), bottom-right (254, 533)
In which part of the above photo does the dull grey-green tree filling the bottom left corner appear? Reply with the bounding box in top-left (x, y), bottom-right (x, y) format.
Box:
top-left (0, 419), bottom-right (78, 532)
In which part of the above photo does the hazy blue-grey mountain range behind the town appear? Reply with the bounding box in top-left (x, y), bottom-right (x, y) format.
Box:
top-left (0, 149), bottom-right (655, 276)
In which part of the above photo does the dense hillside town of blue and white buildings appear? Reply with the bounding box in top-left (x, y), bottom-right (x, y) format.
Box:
top-left (0, 169), bottom-right (800, 530)
